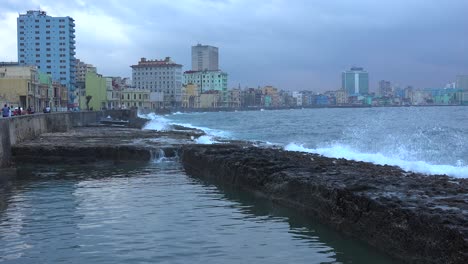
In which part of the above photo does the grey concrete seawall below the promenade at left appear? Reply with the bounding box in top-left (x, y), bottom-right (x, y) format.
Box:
top-left (0, 112), bottom-right (102, 167)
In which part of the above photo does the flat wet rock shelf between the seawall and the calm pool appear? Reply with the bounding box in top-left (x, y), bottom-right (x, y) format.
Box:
top-left (12, 126), bottom-right (204, 163)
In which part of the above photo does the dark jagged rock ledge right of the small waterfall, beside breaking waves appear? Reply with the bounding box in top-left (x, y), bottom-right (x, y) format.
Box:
top-left (181, 144), bottom-right (468, 263)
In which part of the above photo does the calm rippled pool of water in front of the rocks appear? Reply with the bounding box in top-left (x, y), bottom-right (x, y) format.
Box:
top-left (0, 162), bottom-right (396, 264)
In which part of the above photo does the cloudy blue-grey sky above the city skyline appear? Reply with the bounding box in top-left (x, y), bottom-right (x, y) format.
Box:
top-left (0, 0), bottom-right (468, 92)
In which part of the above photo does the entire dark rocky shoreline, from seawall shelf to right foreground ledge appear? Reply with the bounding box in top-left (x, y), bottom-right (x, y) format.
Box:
top-left (7, 122), bottom-right (468, 263)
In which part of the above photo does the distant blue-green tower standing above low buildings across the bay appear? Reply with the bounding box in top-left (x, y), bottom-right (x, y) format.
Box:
top-left (341, 67), bottom-right (369, 96)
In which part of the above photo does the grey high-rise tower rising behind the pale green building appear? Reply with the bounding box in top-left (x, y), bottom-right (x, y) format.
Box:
top-left (192, 44), bottom-right (219, 71)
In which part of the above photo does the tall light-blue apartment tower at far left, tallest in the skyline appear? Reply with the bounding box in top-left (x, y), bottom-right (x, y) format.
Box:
top-left (17, 11), bottom-right (77, 107)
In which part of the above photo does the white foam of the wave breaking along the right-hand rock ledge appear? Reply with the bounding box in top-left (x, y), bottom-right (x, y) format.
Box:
top-left (284, 143), bottom-right (468, 178)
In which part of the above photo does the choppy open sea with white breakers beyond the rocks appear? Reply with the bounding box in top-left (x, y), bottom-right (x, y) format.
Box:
top-left (142, 106), bottom-right (468, 178)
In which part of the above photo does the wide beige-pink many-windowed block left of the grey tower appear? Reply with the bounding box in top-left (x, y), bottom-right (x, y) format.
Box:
top-left (130, 57), bottom-right (182, 107)
